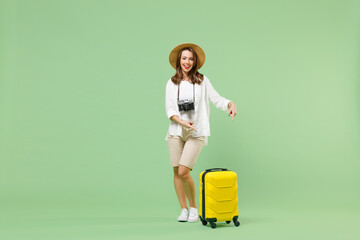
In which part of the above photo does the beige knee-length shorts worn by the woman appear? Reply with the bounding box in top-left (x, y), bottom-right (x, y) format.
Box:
top-left (168, 127), bottom-right (204, 170)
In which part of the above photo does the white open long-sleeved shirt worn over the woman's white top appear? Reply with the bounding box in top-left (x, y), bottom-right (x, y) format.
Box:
top-left (165, 75), bottom-right (231, 146)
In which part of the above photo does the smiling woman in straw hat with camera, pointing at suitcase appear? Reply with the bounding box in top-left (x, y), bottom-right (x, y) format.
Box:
top-left (165, 43), bottom-right (236, 222)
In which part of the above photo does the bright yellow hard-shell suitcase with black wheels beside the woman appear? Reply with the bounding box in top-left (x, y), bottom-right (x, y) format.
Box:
top-left (199, 168), bottom-right (240, 228)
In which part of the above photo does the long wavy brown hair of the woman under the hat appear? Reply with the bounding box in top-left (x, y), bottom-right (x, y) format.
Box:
top-left (171, 47), bottom-right (204, 85)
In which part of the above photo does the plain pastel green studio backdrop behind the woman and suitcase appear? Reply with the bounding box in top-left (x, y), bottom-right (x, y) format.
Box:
top-left (0, 0), bottom-right (360, 240)
